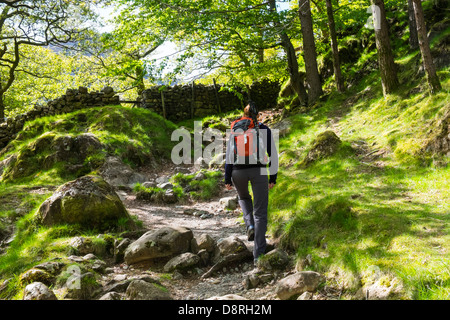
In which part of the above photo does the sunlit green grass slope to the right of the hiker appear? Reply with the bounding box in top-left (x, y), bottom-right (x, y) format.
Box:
top-left (269, 60), bottom-right (450, 299)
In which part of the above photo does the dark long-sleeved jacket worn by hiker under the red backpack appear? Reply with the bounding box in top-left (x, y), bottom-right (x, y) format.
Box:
top-left (225, 123), bottom-right (278, 184)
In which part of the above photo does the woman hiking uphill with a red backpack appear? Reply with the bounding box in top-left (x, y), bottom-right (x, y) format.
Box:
top-left (225, 101), bottom-right (278, 264)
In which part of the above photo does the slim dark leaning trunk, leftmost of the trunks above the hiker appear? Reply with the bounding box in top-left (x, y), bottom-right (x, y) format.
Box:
top-left (269, 0), bottom-right (308, 106)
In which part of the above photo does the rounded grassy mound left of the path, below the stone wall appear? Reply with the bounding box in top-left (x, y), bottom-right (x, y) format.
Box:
top-left (0, 106), bottom-right (176, 180)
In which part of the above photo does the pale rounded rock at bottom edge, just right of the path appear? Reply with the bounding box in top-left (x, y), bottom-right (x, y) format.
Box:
top-left (276, 271), bottom-right (322, 300)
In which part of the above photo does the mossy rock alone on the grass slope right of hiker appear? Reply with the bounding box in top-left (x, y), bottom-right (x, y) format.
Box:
top-left (299, 130), bottom-right (342, 167)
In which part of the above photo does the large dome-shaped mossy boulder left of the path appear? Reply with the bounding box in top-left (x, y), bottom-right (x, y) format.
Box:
top-left (38, 175), bottom-right (134, 230)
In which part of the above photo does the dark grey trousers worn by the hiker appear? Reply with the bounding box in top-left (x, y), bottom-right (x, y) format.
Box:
top-left (232, 167), bottom-right (269, 259)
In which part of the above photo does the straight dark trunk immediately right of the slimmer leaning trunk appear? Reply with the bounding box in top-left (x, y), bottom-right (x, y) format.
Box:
top-left (298, 0), bottom-right (323, 104)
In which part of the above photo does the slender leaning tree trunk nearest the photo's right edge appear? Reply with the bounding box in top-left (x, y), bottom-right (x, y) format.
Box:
top-left (412, 0), bottom-right (442, 93)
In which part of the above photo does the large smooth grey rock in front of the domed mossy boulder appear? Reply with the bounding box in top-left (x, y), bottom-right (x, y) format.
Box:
top-left (124, 227), bottom-right (193, 264)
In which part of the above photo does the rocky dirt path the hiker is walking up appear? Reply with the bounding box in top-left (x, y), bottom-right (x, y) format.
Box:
top-left (110, 162), bottom-right (284, 300)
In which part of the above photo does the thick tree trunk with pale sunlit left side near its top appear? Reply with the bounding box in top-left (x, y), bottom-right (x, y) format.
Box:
top-left (371, 0), bottom-right (399, 96)
